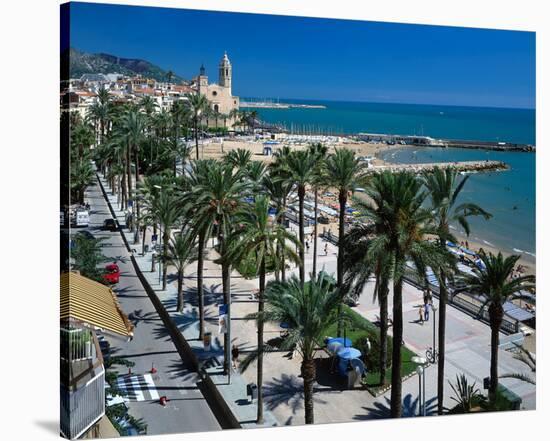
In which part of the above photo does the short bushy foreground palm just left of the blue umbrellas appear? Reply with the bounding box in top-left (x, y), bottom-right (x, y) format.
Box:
top-left (249, 272), bottom-right (340, 424)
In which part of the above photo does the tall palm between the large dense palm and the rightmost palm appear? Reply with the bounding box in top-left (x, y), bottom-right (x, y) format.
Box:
top-left (424, 167), bottom-right (491, 415)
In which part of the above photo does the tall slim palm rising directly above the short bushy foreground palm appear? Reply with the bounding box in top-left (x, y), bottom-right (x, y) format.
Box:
top-left (284, 150), bottom-right (316, 284)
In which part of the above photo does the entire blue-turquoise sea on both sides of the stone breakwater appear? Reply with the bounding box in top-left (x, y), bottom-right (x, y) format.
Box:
top-left (247, 100), bottom-right (536, 261)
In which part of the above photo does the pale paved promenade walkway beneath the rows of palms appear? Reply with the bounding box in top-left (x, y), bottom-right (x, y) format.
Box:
top-left (97, 172), bottom-right (535, 427)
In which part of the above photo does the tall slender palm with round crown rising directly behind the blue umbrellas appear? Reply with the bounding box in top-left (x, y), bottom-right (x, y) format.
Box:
top-left (326, 148), bottom-right (365, 335)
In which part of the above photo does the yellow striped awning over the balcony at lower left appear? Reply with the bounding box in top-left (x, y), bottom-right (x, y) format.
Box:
top-left (60, 272), bottom-right (134, 337)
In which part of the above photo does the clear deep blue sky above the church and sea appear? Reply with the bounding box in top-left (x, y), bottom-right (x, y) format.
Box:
top-left (67, 3), bottom-right (535, 108)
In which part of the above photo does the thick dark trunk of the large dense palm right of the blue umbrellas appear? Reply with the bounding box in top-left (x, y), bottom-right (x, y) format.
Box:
top-left (391, 278), bottom-right (403, 418)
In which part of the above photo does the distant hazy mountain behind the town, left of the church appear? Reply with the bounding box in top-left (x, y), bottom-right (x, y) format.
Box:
top-left (66, 48), bottom-right (188, 83)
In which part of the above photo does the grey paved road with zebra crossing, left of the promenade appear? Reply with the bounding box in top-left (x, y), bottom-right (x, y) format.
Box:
top-left (86, 179), bottom-right (221, 435)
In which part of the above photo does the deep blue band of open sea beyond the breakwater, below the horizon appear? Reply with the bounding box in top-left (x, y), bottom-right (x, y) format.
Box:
top-left (248, 100), bottom-right (535, 144)
